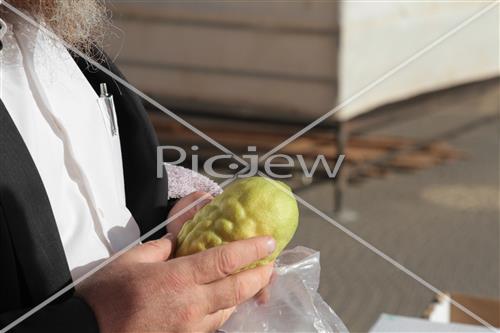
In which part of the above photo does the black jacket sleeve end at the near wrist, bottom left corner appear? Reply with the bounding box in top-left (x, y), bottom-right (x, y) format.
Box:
top-left (0, 296), bottom-right (99, 333)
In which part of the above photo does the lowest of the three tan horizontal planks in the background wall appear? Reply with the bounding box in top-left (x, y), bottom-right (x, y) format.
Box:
top-left (121, 66), bottom-right (336, 119)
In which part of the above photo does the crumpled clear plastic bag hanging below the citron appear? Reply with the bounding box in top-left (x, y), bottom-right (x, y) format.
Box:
top-left (219, 246), bottom-right (348, 333)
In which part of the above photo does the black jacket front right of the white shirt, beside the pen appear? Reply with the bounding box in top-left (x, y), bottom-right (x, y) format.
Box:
top-left (74, 50), bottom-right (168, 239)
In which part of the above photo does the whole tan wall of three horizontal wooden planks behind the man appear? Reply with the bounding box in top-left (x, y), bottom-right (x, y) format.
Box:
top-left (107, 1), bottom-right (339, 119)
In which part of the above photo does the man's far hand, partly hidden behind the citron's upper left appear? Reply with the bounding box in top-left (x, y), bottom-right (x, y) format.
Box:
top-left (167, 191), bottom-right (213, 239)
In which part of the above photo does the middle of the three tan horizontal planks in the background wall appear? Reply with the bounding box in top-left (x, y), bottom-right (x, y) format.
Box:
top-left (111, 20), bottom-right (337, 80)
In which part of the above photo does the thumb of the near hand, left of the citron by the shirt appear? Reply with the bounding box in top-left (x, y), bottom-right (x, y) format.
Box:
top-left (124, 234), bottom-right (174, 263)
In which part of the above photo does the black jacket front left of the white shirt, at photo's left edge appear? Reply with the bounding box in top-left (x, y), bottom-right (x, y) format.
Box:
top-left (0, 101), bottom-right (71, 303)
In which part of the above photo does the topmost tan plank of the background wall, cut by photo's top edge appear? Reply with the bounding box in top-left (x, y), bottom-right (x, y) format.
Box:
top-left (111, 0), bottom-right (339, 31)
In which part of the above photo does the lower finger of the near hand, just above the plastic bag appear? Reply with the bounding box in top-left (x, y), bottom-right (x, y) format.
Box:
top-left (204, 265), bottom-right (273, 312)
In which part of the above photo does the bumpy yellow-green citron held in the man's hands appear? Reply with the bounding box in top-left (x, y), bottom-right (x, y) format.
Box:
top-left (176, 177), bottom-right (299, 268)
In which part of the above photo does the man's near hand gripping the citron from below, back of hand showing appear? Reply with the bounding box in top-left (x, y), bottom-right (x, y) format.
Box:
top-left (77, 236), bottom-right (275, 333)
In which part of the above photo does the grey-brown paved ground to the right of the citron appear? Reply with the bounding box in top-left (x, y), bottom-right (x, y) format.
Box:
top-left (292, 79), bottom-right (500, 332)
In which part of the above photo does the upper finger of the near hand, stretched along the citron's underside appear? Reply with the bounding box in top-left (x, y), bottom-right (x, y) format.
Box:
top-left (187, 236), bottom-right (276, 284)
